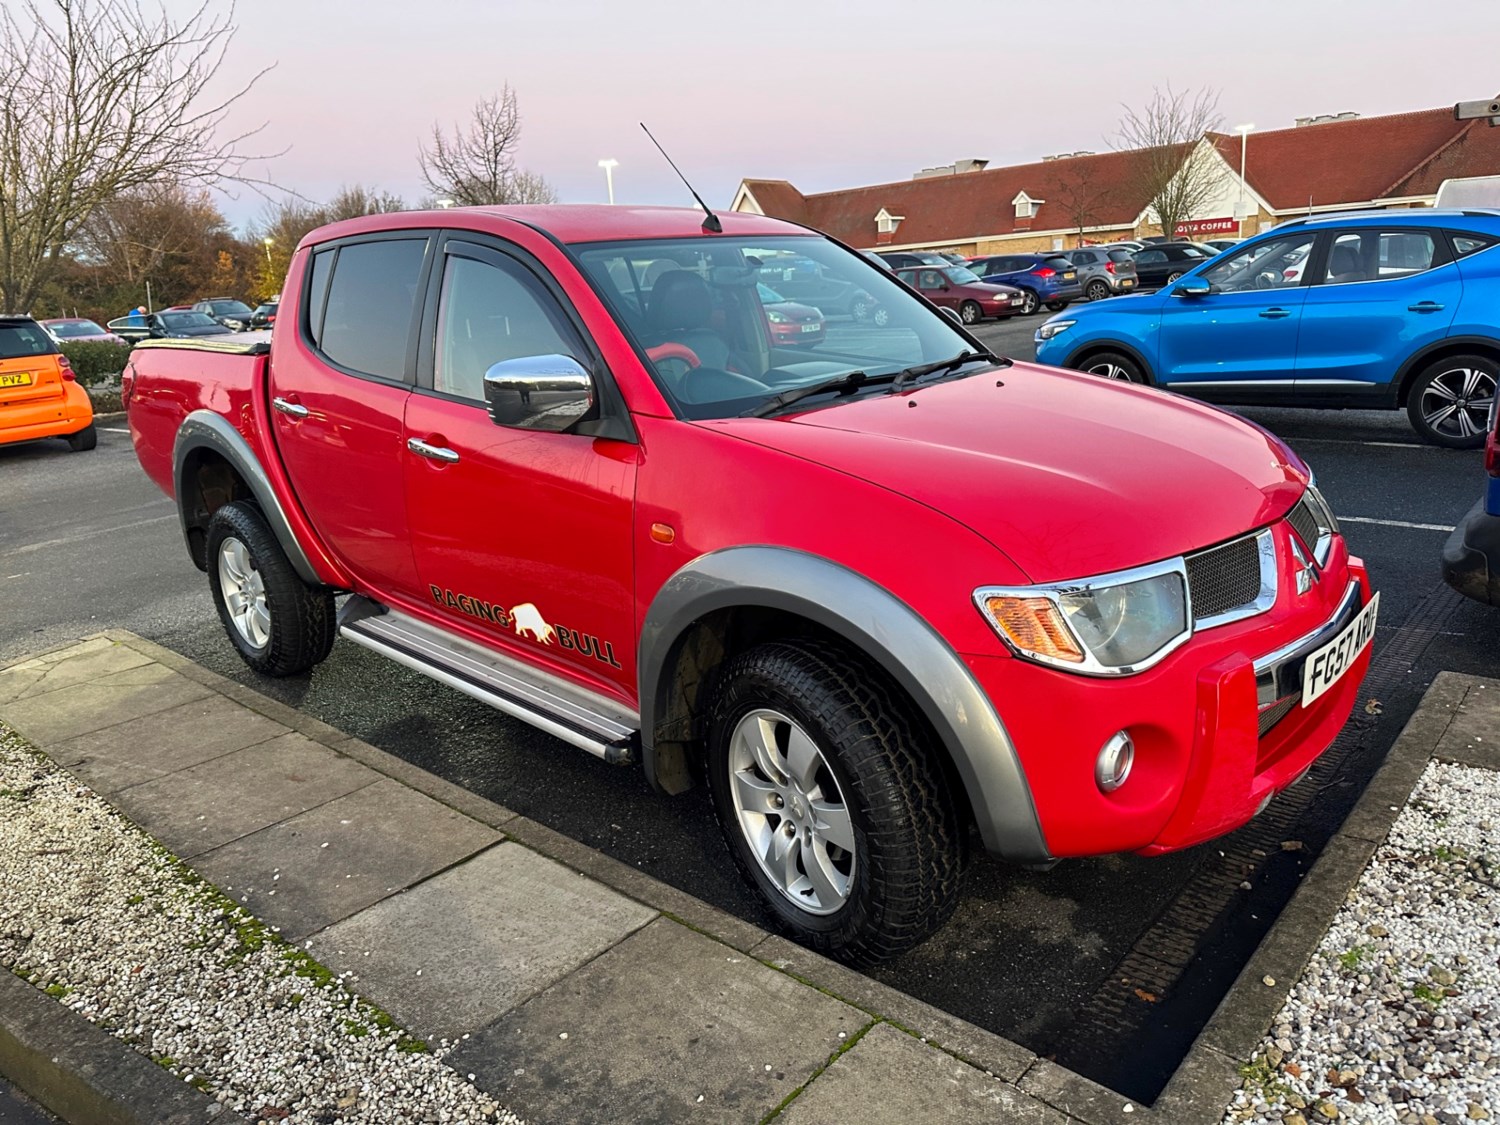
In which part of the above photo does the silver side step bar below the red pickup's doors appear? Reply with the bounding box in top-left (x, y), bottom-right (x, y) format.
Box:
top-left (339, 594), bottom-right (641, 765)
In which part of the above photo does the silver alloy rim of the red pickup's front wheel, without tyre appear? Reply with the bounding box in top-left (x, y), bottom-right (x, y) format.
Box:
top-left (729, 708), bottom-right (858, 915)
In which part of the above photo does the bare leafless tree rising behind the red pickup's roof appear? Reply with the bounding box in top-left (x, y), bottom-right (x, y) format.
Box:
top-left (417, 84), bottom-right (557, 207)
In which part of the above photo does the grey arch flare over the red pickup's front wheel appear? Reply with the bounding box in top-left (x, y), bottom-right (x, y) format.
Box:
top-left (638, 546), bottom-right (1052, 864)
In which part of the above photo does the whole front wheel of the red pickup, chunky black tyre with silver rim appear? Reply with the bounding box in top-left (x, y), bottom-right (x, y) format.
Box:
top-left (708, 642), bottom-right (965, 965)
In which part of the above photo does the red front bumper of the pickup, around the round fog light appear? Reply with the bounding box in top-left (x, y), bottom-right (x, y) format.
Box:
top-left (969, 537), bottom-right (1371, 858)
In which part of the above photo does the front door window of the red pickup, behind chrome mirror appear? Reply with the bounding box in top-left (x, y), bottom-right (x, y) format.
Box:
top-left (435, 254), bottom-right (581, 402)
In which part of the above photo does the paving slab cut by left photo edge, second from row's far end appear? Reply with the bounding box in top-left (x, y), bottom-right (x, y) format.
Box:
top-left (0, 663), bottom-right (209, 749)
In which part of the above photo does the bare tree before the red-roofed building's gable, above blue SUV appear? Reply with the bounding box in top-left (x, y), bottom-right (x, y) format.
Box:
top-left (1116, 86), bottom-right (1221, 239)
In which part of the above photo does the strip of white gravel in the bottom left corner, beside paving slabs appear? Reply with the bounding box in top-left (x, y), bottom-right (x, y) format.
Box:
top-left (0, 725), bottom-right (519, 1125)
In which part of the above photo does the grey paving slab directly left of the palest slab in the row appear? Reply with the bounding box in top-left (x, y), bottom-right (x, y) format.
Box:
top-left (196, 774), bottom-right (501, 942)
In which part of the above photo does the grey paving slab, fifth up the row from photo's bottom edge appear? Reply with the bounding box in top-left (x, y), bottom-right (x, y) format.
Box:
top-left (111, 734), bottom-right (381, 860)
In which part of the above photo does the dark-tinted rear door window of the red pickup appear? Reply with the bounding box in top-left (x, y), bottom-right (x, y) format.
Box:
top-left (318, 239), bottom-right (428, 380)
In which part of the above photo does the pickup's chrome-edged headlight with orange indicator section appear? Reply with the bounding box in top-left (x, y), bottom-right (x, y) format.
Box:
top-left (974, 560), bottom-right (1193, 677)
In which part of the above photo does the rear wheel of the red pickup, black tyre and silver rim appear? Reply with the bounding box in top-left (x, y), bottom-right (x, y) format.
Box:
top-left (207, 501), bottom-right (335, 677)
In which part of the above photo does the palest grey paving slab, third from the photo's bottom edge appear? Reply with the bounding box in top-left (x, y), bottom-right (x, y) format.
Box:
top-left (307, 846), bottom-right (657, 1040)
